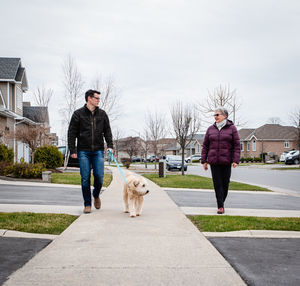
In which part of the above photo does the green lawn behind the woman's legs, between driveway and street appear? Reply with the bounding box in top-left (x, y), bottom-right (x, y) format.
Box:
top-left (143, 174), bottom-right (271, 192)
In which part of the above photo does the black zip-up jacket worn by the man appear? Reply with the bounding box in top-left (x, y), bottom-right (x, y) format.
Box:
top-left (68, 104), bottom-right (113, 154)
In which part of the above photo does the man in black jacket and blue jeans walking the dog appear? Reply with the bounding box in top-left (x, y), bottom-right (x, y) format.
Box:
top-left (68, 89), bottom-right (113, 213)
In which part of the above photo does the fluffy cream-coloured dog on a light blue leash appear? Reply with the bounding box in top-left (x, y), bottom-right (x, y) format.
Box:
top-left (123, 174), bottom-right (149, 217)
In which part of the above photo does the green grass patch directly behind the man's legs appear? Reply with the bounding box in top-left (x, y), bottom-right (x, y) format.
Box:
top-left (51, 172), bottom-right (112, 187)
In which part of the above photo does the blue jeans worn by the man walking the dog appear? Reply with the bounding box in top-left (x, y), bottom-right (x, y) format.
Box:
top-left (78, 150), bottom-right (104, 206)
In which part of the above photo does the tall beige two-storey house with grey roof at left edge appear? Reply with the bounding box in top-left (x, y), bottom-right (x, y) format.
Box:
top-left (0, 57), bottom-right (56, 162)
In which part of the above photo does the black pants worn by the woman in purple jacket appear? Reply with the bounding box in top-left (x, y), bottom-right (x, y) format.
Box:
top-left (210, 165), bottom-right (231, 208)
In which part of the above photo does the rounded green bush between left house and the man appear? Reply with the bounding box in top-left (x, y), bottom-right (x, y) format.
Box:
top-left (34, 145), bottom-right (64, 169)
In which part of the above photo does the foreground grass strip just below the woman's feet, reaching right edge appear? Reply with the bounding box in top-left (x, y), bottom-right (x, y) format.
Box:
top-left (187, 215), bottom-right (300, 232)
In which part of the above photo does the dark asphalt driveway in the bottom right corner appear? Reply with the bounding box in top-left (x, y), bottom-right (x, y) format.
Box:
top-left (209, 237), bottom-right (300, 286)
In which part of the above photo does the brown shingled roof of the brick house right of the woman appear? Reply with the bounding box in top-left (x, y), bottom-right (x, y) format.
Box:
top-left (239, 124), bottom-right (297, 140)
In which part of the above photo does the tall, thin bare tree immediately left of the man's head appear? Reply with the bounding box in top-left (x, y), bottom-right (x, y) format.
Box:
top-left (60, 55), bottom-right (84, 168)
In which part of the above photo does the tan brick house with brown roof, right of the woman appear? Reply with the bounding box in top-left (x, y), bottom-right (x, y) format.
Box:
top-left (238, 124), bottom-right (298, 158)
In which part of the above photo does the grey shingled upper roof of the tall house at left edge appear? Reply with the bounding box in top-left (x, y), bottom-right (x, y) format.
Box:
top-left (0, 57), bottom-right (28, 91)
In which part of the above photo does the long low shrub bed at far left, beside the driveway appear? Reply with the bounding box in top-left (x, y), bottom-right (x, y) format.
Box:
top-left (4, 163), bottom-right (45, 179)
